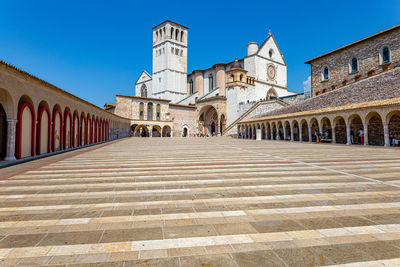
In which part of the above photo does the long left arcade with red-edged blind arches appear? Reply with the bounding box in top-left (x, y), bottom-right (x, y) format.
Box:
top-left (0, 61), bottom-right (130, 160)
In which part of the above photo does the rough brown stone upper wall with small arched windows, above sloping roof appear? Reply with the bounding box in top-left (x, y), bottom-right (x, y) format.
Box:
top-left (311, 28), bottom-right (400, 96)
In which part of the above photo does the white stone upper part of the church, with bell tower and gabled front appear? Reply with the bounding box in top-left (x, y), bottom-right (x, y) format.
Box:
top-left (135, 20), bottom-right (296, 136)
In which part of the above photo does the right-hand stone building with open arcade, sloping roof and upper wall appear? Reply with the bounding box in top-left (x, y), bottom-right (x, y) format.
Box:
top-left (238, 25), bottom-right (400, 146)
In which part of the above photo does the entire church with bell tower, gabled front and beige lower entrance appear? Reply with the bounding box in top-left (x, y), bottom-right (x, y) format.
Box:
top-left (105, 20), bottom-right (298, 136)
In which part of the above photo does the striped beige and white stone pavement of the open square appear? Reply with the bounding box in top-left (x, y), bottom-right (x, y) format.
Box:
top-left (0, 138), bottom-right (400, 267)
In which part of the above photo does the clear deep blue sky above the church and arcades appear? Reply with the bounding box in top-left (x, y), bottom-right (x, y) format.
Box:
top-left (0, 0), bottom-right (400, 107)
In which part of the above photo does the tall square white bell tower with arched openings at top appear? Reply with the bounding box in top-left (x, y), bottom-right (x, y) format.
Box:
top-left (152, 20), bottom-right (188, 103)
